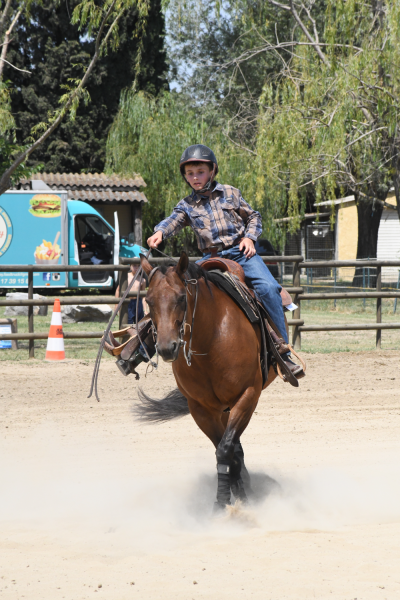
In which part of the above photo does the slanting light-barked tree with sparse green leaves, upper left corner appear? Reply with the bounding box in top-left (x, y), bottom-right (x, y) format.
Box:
top-left (0, 0), bottom-right (162, 194)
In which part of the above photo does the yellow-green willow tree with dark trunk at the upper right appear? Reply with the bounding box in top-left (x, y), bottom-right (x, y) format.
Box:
top-left (245, 0), bottom-right (400, 258)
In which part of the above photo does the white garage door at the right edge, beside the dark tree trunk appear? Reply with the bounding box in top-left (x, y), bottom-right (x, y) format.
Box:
top-left (378, 210), bottom-right (400, 283)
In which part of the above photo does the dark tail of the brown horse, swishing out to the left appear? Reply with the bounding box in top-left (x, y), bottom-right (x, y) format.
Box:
top-left (133, 388), bottom-right (190, 423)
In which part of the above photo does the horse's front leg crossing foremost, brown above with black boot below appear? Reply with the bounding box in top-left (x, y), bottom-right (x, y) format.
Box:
top-left (215, 388), bottom-right (261, 510)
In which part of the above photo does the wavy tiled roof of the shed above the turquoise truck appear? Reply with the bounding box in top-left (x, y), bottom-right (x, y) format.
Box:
top-left (19, 173), bottom-right (147, 202)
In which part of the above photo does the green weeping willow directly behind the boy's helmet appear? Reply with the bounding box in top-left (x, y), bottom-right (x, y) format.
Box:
top-left (107, 89), bottom-right (254, 254)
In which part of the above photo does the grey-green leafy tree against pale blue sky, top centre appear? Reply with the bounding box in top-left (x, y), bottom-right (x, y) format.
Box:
top-left (166, 0), bottom-right (290, 148)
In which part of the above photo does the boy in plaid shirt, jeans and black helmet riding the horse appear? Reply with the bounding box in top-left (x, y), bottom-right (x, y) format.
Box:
top-left (147, 144), bottom-right (304, 378)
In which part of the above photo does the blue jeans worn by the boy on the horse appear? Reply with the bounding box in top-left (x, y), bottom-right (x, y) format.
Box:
top-left (203, 246), bottom-right (289, 342)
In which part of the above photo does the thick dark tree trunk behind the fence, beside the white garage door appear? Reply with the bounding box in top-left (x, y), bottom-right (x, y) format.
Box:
top-left (353, 192), bottom-right (387, 288)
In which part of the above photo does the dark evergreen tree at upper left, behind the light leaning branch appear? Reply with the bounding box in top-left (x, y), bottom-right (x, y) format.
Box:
top-left (4, 0), bottom-right (166, 172)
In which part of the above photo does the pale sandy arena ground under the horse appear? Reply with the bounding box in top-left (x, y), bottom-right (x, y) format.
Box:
top-left (0, 352), bottom-right (400, 600)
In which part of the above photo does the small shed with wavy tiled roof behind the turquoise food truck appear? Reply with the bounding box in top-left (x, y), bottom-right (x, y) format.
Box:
top-left (18, 173), bottom-right (147, 245)
